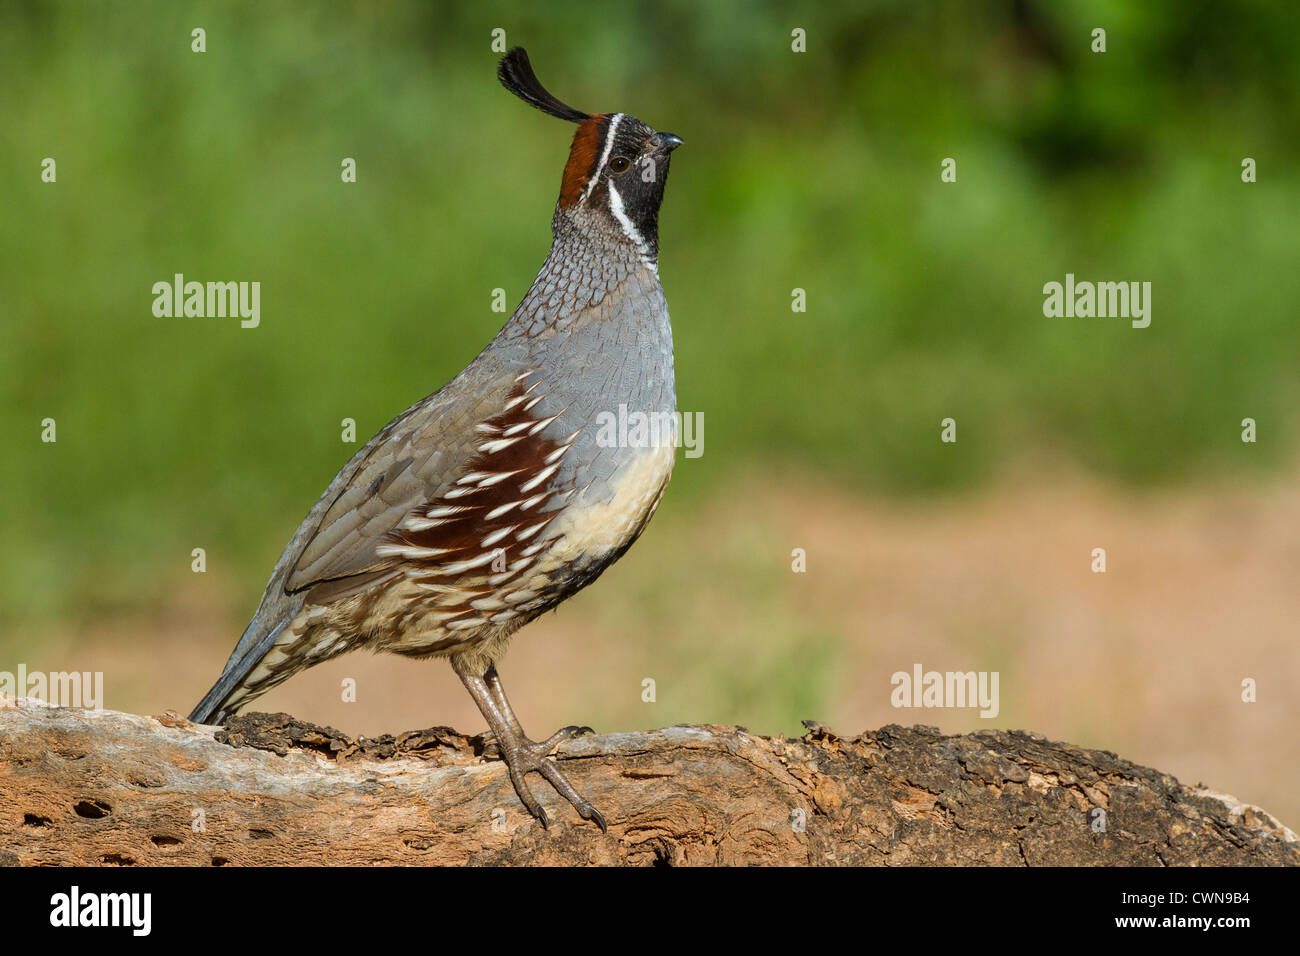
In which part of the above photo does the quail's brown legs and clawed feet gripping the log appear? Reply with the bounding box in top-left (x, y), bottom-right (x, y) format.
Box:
top-left (460, 666), bottom-right (608, 831)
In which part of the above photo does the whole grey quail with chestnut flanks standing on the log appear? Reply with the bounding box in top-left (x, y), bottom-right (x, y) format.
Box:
top-left (190, 47), bottom-right (683, 831)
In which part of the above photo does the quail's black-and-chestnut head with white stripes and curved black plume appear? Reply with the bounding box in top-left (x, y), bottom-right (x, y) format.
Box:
top-left (497, 47), bottom-right (681, 260)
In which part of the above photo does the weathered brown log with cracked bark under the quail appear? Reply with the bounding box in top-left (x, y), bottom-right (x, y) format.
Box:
top-left (0, 700), bottom-right (1300, 866)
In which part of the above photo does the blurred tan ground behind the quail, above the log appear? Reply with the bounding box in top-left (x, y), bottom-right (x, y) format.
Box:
top-left (26, 468), bottom-right (1300, 827)
